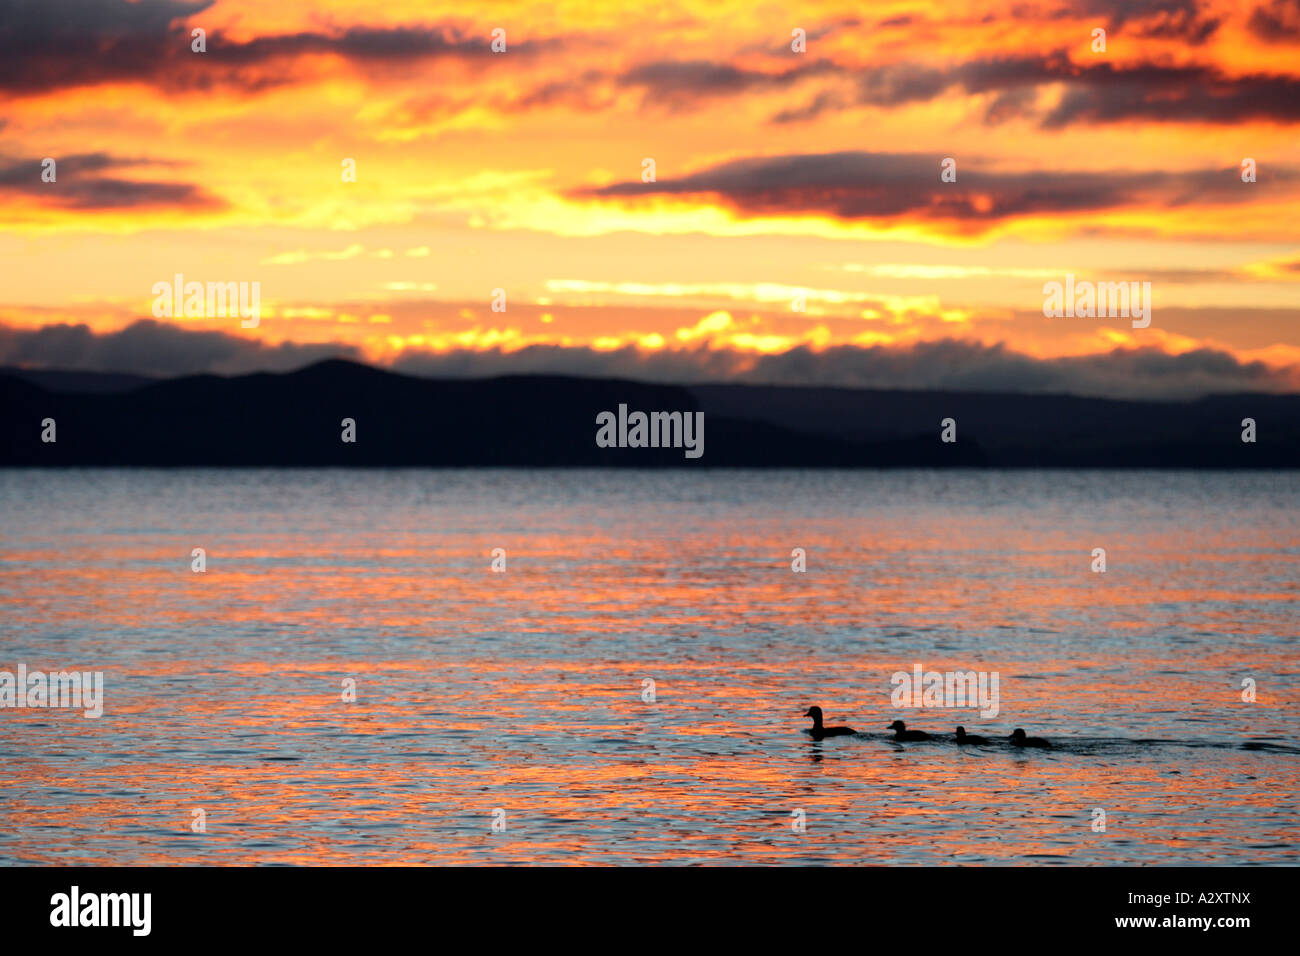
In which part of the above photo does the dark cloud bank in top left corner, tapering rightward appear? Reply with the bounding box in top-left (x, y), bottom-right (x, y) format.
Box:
top-left (0, 0), bottom-right (553, 94)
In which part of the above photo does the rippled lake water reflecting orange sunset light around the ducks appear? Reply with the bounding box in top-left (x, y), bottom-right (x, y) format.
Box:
top-left (0, 470), bottom-right (1300, 864)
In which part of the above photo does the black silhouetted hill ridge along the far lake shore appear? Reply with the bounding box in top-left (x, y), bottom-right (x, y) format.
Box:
top-left (0, 360), bottom-right (1300, 468)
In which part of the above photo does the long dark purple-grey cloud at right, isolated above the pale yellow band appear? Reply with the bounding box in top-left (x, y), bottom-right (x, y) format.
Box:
top-left (572, 152), bottom-right (1300, 222)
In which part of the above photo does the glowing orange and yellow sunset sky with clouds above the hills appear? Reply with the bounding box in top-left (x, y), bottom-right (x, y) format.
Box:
top-left (0, 0), bottom-right (1300, 395)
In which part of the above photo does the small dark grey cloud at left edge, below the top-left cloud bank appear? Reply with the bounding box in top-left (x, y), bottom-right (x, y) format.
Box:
top-left (0, 152), bottom-right (224, 211)
